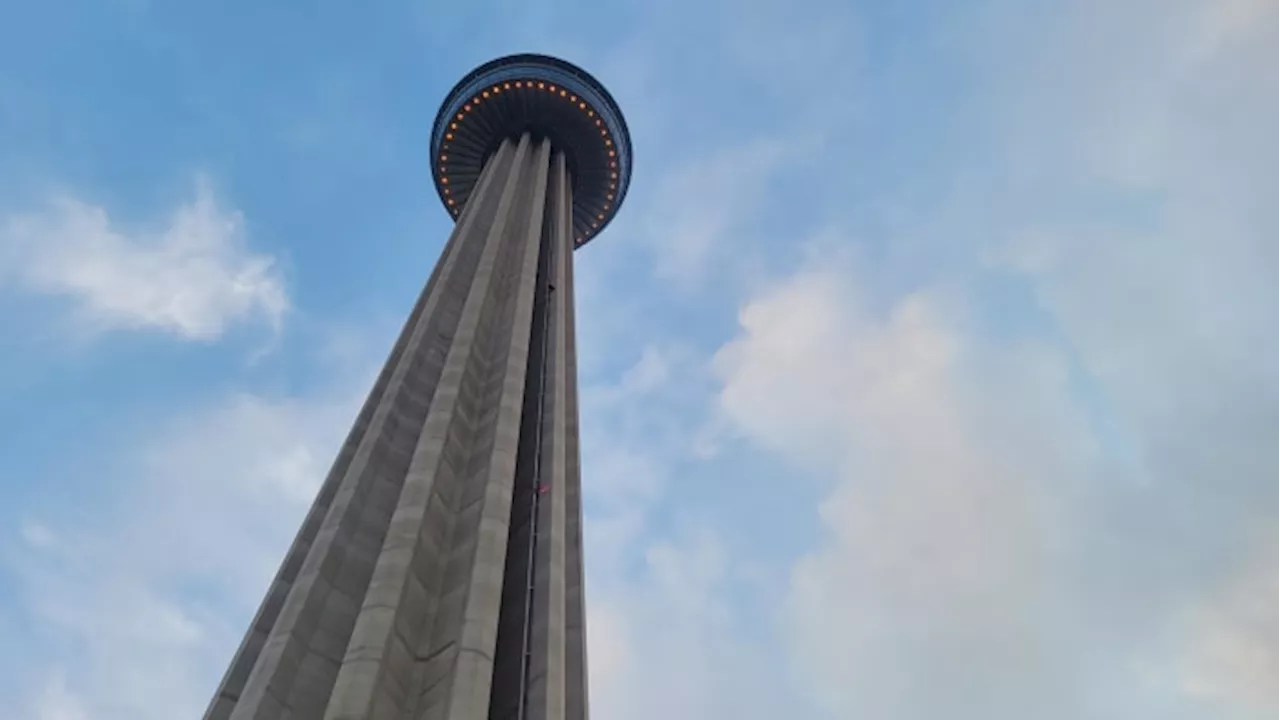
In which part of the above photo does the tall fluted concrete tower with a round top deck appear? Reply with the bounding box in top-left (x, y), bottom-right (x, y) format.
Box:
top-left (205, 55), bottom-right (631, 720)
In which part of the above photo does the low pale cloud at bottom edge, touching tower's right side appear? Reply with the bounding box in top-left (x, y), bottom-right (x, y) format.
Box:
top-left (588, 530), bottom-right (804, 720)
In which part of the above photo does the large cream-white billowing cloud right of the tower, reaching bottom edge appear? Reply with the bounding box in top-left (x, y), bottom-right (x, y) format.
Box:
top-left (717, 266), bottom-right (1089, 719)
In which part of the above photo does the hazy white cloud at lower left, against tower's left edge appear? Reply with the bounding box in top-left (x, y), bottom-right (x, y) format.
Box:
top-left (13, 381), bottom-right (367, 720)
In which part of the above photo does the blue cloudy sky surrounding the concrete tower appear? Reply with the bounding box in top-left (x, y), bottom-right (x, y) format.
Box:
top-left (0, 0), bottom-right (1280, 720)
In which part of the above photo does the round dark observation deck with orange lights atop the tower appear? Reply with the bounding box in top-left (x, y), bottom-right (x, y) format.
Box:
top-left (431, 54), bottom-right (631, 245)
